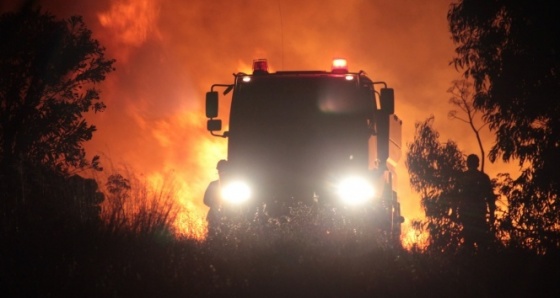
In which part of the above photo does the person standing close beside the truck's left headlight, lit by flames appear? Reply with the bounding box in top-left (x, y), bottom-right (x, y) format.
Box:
top-left (203, 159), bottom-right (227, 236)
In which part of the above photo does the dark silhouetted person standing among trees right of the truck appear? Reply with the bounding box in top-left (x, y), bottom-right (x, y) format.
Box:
top-left (457, 154), bottom-right (496, 250)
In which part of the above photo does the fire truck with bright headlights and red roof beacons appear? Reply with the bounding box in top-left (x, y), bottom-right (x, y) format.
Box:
top-left (206, 59), bottom-right (404, 243)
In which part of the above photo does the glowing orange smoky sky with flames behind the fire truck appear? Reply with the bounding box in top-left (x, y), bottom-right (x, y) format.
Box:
top-left (0, 0), bottom-right (510, 235)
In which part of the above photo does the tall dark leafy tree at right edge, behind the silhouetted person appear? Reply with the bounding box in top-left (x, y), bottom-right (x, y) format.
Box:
top-left (448, 0), bottom-right (560, 249)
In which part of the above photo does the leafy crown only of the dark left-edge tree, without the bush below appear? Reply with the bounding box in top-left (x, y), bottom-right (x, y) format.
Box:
top-left (0, 8), bottom-right (114, 173)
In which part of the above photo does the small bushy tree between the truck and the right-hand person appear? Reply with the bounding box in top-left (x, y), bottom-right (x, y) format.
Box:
top-left (405, 116), bottom-right (464, 252)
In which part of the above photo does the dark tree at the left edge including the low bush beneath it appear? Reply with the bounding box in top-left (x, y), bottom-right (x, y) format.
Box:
top-left (0, 6), bottom-right (115, 230)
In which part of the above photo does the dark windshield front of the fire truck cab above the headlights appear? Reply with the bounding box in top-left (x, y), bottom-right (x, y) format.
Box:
top-left (228, 75), bottom-right (374, 198)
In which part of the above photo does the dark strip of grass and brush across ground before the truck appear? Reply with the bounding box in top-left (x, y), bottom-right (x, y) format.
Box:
top-left (0, 193), bottom-right (560, 297)
